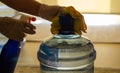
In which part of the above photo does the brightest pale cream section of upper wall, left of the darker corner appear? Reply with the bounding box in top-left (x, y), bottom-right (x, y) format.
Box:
top-left (58, 0), bottom-right (110, 13)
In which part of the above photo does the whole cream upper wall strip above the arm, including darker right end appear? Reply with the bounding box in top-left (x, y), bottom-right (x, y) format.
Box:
top-left (37, 0), bottom-right (120, 13)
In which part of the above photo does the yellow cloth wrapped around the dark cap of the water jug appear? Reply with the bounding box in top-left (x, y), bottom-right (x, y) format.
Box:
top-left (51, 6), bottom-right (87, 35)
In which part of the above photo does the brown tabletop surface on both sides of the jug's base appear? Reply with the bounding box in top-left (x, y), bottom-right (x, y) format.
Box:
top-left (15, 66), bottom-right (120, 73)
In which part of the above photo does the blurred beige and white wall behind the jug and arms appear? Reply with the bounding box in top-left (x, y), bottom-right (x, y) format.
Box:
top-left (0, 0), bottom-right (120, 69)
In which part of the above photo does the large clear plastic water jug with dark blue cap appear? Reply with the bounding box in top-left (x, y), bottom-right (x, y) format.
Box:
top-left (37, 14), bottom-right (96, 73)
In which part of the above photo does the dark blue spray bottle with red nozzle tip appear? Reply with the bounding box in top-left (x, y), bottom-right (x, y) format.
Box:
top-left (0, 15), bottom-right (35, 73)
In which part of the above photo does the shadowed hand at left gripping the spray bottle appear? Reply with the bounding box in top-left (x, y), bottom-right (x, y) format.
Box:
top-left (0, 17), bottom-right (35, 41)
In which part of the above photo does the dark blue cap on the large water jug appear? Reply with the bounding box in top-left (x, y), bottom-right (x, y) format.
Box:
top-left (59, 14), bottom-right (74, 35)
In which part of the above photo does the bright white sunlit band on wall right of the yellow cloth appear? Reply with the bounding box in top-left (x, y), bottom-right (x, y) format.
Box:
top-left (83, 14), bottom-right (120, 26)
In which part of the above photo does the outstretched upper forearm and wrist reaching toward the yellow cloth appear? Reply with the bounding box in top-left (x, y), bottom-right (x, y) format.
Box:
top-left (1, 0), bottom-right (62, 20)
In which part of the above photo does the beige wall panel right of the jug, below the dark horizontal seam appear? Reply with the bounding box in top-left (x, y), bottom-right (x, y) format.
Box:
top-left (94, 43), bottom-right (120, 69)
